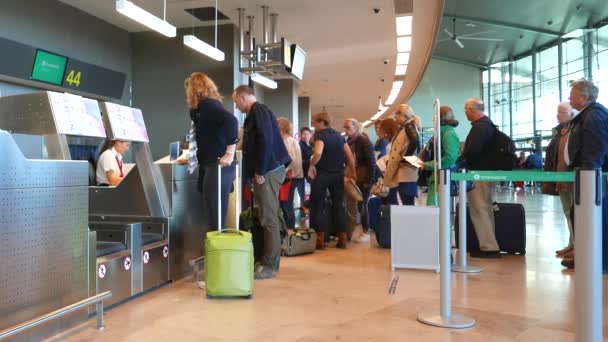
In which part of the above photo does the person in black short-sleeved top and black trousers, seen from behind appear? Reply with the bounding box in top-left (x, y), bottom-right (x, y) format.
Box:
top-left (308, 112), bottom-right (356, 249)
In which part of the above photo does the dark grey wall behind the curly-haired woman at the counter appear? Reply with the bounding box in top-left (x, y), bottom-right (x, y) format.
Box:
top-left (132, 24), bottom-right (238, 159)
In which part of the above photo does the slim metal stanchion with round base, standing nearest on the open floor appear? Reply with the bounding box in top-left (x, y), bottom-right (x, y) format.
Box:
top-left (418, 170), bottom-right (475, 329)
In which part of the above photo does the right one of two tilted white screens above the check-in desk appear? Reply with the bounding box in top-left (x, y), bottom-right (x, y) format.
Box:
top-left (106, 102), bottom-right (149, 142)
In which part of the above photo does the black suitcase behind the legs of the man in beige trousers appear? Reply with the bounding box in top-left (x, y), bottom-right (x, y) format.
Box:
top-left (454, 202), bottom-right (526, 255)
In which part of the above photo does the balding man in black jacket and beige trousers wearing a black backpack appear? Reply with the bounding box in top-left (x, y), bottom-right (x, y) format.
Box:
top-left (457, 98), bottom-right (517, 258)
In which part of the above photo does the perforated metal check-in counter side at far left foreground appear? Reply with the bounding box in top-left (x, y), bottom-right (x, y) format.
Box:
top-left (0, 131), bottom-right (89, 341)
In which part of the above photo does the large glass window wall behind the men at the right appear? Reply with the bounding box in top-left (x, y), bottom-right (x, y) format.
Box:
top-left (482, 21), bottom-right (608, 147)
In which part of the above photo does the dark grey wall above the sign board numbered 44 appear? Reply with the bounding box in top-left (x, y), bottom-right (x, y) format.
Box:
top-left (0, 0), bottom-right (131, 104)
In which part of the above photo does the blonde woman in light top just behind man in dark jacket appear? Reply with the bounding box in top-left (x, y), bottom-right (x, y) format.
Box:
top-left (277, 118), bottom-right (304, 229)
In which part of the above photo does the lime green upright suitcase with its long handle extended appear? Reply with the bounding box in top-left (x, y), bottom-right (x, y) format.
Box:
top-left (205, 165), bottom-right (253, 298)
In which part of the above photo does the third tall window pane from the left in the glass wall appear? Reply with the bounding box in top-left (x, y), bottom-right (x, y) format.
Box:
top-left (536, 46), bottom-right (560, 135)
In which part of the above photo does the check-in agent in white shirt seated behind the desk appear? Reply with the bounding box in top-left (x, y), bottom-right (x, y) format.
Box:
top-left (96, 140), bottom-right (130, 186)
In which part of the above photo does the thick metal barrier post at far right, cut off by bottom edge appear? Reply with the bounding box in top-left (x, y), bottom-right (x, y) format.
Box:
top-left (574, 169), bottom-right (604, 342)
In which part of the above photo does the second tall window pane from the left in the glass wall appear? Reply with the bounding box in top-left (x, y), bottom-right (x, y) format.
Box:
top-left (513, 56), bottom-right (534, 138)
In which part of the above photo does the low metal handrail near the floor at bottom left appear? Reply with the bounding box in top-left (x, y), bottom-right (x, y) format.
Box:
top-left (0, 291), bottom-right (112, 340)
